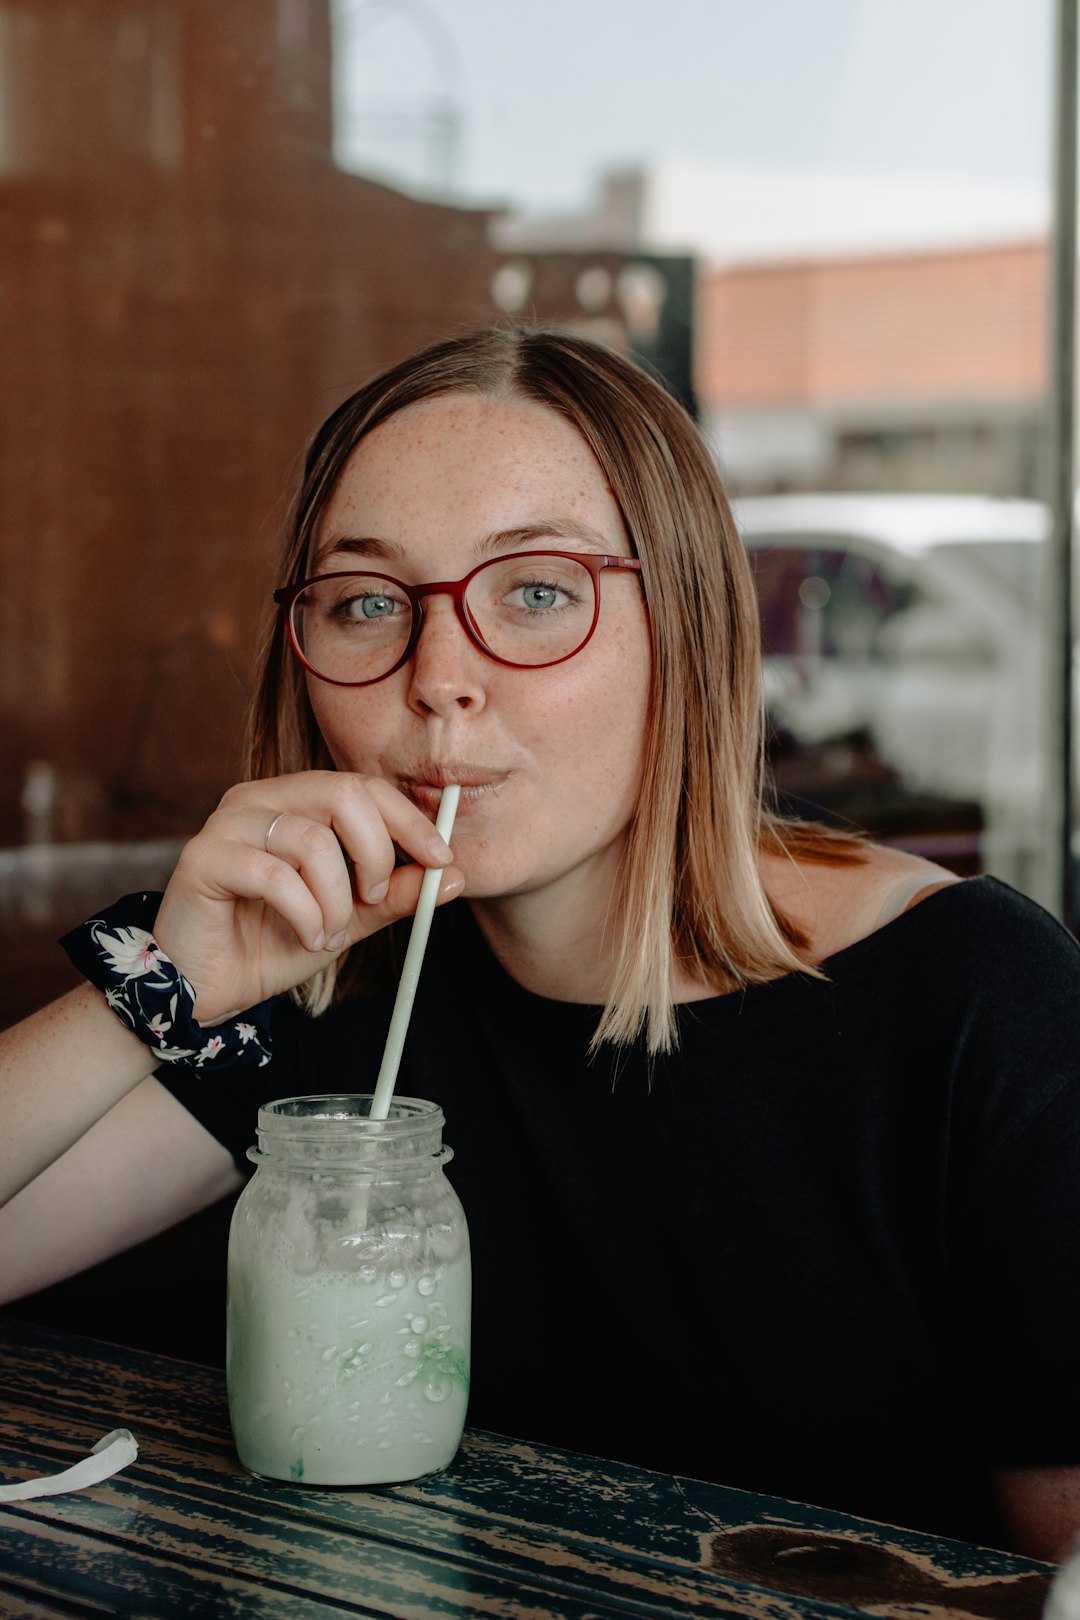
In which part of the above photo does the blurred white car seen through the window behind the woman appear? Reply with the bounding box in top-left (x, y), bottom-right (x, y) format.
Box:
top-left (735, 494), bottom-right (1048, 889)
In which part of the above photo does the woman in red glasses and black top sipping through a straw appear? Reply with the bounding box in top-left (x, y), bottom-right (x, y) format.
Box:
top-left (0, 330), bottom-right (1080, 1555)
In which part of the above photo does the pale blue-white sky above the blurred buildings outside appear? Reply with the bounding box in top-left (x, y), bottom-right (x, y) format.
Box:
top-left (335, 0), bottom-right (1052, 212)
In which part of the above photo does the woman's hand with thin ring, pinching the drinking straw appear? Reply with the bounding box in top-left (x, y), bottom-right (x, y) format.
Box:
top-left (154, 771), bottom-right (465, 1027)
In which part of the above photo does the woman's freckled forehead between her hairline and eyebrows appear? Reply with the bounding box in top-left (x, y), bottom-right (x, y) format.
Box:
top-left (321, 394), bottom-right (625, 549)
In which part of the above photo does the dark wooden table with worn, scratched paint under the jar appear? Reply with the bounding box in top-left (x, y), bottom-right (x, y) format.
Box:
top-left (0, 1319), bottom-right (1052, 1620)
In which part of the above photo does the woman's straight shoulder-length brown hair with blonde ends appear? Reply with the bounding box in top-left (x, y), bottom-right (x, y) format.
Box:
top-left (248, 327), bottom-right (861, 1051)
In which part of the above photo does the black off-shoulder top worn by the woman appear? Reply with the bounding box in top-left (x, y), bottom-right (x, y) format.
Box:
top-left (159, 878), bottom-right (1080, 1544)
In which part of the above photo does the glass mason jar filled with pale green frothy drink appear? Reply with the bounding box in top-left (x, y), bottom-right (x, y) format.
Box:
top-left (227, 1097), bottom-right (471, 1486)
